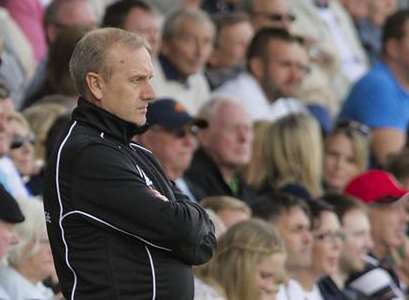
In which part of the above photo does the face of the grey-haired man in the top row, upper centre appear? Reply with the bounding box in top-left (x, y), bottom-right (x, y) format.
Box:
top-left (163, 18), bottom-right (214, 76)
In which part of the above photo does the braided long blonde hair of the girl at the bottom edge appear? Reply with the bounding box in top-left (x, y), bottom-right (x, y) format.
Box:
top-left (198, 219), bottom-right (285, 300)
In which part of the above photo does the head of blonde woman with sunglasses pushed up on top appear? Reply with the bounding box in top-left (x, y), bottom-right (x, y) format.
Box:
top-left (324, 121), bottom-right (369, 193)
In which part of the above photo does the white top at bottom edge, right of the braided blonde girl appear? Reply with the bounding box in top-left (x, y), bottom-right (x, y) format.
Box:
top-left (277, 279), bottom-right (324, 300)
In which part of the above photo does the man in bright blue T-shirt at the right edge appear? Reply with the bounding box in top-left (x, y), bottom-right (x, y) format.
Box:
top-left (341, 10), bottom-right (409, 166)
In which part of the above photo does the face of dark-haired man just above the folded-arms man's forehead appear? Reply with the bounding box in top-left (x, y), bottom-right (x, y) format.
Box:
top-left (124, 8), bottom-right (160, 57)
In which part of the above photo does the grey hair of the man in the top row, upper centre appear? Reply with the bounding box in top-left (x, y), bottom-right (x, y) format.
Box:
top-left (162, 8), bottom-right (216, 41)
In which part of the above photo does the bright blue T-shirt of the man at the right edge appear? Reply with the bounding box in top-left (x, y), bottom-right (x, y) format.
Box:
top-left (340, 62), bottom-right (409, 132)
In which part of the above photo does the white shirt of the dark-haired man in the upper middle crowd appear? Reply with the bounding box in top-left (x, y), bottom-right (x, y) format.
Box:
top-left (212, 72), bottom-right (307, 121)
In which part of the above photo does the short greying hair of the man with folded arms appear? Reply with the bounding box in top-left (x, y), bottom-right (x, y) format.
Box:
top-left (70, 27), bottom-right (149, 97)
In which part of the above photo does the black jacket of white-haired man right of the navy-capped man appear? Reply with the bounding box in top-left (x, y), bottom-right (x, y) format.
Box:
top-left (185, 148), bottom-right (256, 204)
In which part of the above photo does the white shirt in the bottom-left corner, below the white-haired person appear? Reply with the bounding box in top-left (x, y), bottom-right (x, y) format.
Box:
top-left (0, 266), bottom-right (54, 300)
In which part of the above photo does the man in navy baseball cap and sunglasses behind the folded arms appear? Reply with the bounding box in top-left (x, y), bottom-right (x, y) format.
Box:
top-left (138, 98), bottom-right (208, 201)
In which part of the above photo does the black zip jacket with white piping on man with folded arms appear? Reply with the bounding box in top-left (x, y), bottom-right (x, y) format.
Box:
top-left (44, 98), bottom-right (216, 300)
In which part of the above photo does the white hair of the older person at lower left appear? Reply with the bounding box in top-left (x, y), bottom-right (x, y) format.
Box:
top-left (7, 198), bottom-right (47, 267)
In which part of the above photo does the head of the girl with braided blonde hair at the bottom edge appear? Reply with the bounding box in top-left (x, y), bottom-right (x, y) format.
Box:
top-left (198, 219), bottom-right (286, 300)
